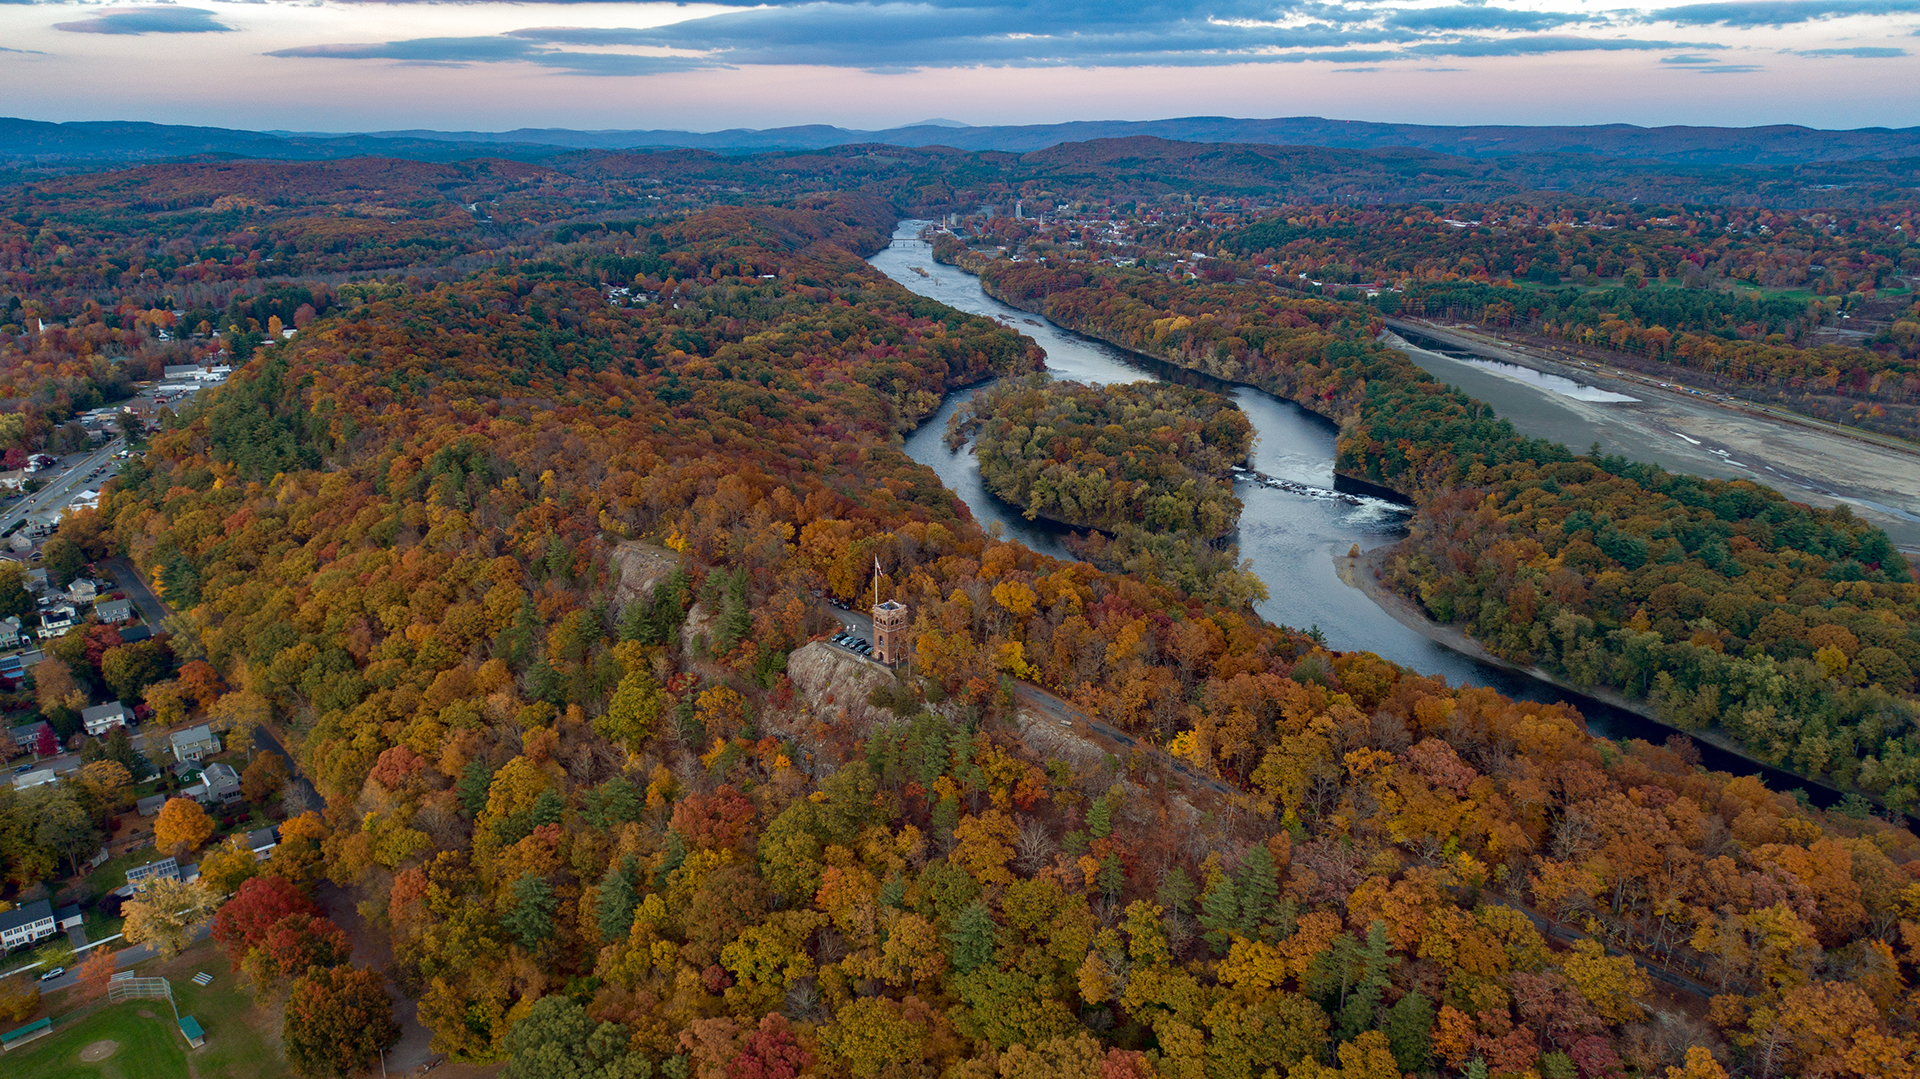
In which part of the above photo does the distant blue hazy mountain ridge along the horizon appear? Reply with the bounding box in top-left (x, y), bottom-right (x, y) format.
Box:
top-left (11, 117), bottom-right (1920, 165)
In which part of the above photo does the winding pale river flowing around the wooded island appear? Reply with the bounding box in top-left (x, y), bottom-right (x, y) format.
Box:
top-left (868, 221), bottom-right (1837, 804)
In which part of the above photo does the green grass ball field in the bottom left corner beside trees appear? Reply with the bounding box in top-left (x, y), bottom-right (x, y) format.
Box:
top-left (0, 943), bottom-right (290, 1079)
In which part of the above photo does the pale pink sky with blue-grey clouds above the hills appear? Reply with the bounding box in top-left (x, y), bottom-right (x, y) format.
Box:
top-left (0, 0), bottom-right (1920, 132)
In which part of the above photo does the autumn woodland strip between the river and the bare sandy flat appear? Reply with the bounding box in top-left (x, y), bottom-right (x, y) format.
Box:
top-left (941, 242), bottom-right (1920, 808)
